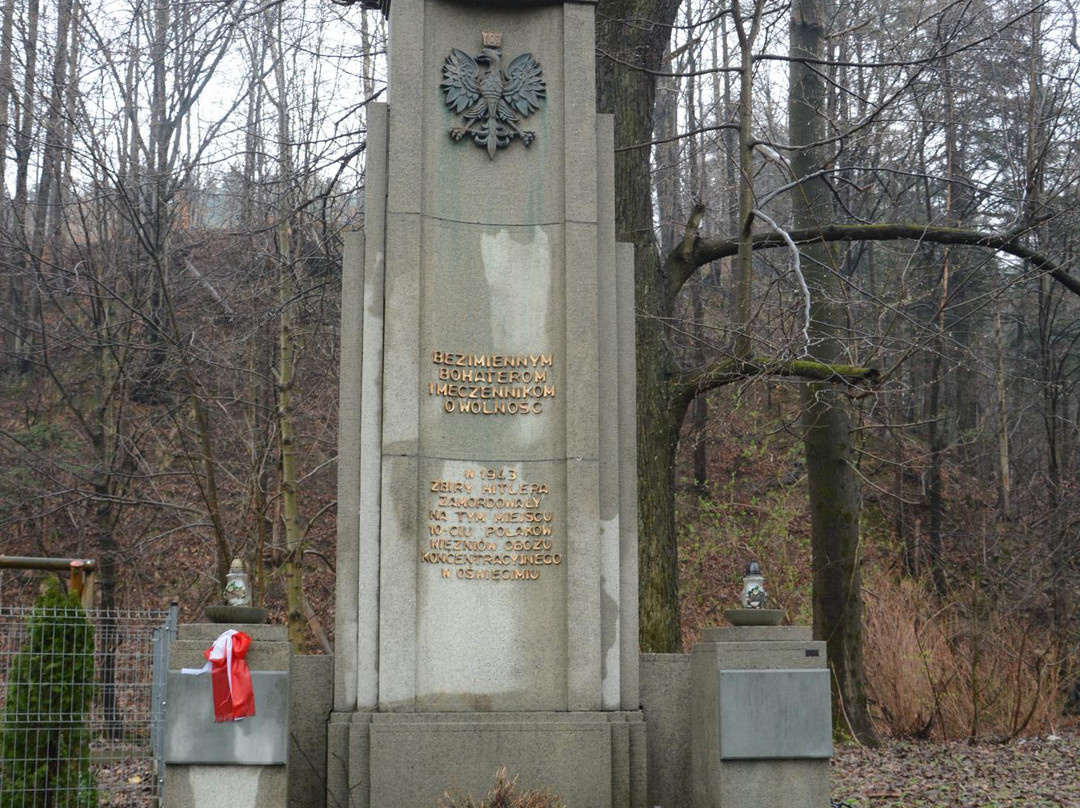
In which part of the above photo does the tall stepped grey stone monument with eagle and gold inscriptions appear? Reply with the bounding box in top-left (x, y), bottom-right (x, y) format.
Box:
top-left (327, 0), bottom-right (646, 808)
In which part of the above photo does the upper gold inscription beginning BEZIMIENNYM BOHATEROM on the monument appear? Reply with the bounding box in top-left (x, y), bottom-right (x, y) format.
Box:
top-left (428, 351), bottom-right (555, 415)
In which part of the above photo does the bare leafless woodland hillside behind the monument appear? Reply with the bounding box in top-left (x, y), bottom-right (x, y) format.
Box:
top-left (0, 0), bottom-right (1080, 740)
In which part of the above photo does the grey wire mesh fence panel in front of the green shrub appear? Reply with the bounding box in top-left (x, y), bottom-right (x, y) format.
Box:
top-left (0, 606), bottom-right (176, 808)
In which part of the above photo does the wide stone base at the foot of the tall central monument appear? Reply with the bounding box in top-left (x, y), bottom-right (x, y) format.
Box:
top-left (327, 712), bottom-right (646, 808)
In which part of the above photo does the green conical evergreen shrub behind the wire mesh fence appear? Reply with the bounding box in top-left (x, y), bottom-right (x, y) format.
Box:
top-left (0, 581), bottom-right (97, 808)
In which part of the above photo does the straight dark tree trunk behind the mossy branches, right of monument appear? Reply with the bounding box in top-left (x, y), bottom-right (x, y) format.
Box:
top-left (788, 0), bottom-right (874, 741)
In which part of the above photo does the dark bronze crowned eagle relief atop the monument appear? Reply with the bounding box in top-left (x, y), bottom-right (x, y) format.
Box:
top-left (440, 31), bottom-right (546, 160)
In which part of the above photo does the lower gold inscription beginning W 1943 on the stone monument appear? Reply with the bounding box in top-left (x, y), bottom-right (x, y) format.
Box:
top-left (420, 468), bottom-right (563, 582)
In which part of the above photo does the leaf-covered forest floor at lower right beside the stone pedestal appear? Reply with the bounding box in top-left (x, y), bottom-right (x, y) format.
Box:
top-left (832, 727), bottom-right (1080, 808)
